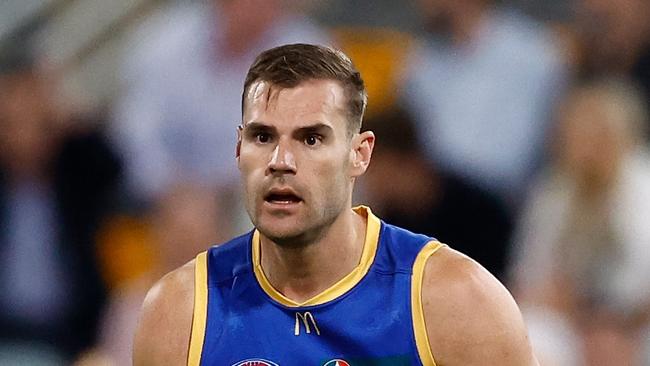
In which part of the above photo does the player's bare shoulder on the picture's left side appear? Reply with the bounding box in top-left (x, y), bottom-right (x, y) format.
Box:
top-left (133, 260), bottom-right (195, 366)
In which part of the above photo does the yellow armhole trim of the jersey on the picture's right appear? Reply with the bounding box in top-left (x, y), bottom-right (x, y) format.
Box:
top-left (411, 241), bottom-right (445, 366)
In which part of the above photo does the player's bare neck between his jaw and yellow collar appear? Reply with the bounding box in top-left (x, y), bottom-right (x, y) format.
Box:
top-left (260, 206), bottom-right (367, 303)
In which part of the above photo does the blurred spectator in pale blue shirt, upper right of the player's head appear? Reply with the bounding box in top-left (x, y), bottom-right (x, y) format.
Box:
top-left (404, 0), bottom-right (565, 205)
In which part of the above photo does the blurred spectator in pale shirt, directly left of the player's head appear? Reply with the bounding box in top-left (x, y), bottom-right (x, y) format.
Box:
top-left (110, 0), bottom-right (329, 206)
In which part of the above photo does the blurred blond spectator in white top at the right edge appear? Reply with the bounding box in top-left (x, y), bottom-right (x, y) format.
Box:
top-left (513, 80), bottom-right (650, 365)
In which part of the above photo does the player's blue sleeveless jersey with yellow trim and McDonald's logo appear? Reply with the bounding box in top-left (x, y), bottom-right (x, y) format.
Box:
top-left (188, 206), bottom-right (442, 366)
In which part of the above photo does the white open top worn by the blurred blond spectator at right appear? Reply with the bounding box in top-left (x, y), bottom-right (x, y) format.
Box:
top-left (513, 149), bottom-right (650, 314)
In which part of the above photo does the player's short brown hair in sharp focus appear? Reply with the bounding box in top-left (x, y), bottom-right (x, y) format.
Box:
top-left (242, 43), bottom-right (368, 132)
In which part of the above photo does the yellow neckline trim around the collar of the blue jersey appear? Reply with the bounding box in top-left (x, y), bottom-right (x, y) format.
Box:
top-left (252, 206), bottom-right (381, 307)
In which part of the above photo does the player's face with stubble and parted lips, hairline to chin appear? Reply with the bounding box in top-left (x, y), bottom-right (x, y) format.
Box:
top-left (237, 80), bottom-right (374, 244)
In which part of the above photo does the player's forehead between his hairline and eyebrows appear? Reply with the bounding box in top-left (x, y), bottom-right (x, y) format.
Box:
top-left (243, 79), bottom-right (347, 127)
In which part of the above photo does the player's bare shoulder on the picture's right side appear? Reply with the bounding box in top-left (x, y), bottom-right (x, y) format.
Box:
top-left (422, 247), bottom-right (537, 366)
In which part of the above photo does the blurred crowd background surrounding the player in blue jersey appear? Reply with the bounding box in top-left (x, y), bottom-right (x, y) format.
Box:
top-left (0, 0), bottom-right (650, 366)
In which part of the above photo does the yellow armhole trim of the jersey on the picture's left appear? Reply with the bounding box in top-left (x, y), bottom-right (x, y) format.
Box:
top-left (187, 252), bottom-right (208, 366)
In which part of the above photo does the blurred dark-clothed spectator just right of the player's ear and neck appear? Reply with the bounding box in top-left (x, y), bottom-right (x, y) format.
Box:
top-left (363, 109), bottom-right (511, 276)
